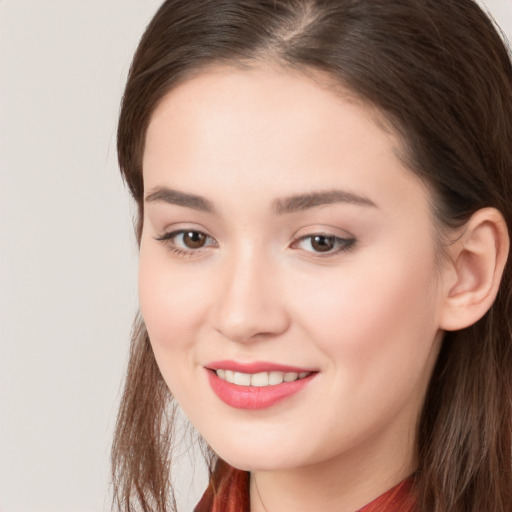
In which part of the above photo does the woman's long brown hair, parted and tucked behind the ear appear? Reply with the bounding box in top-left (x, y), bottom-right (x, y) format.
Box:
top-left (112, 0), bottom-right (512, 512)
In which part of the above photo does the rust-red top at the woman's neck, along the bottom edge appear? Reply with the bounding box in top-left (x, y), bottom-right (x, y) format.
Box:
top-left (194, 460), bottom-right (415, 512)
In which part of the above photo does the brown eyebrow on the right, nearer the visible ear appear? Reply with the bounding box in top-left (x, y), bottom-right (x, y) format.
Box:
top-left (273, 190), bottom-right (377, 215)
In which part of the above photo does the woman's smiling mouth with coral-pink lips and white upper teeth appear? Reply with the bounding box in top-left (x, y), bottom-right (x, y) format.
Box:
top-left (206, 361), bottom-right (318, 410)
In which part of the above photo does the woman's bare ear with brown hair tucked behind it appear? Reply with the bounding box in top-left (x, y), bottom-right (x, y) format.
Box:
top-left (440, 208), bottom-right (510, 331)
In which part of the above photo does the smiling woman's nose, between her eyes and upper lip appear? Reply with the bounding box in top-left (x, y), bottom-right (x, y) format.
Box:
top-left (212, 248), bottom-right (290, 343)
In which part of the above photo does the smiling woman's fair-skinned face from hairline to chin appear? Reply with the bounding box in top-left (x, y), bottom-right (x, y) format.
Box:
top-left (139, 67), bottom-right (448, 476)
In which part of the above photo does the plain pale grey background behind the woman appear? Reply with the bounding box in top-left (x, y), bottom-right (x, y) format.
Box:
top-left (0, 0), bottom-right (512, 512)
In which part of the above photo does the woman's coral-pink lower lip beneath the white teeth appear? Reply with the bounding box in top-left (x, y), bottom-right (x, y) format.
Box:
top-left (208, 370), bottom-right (316, 410)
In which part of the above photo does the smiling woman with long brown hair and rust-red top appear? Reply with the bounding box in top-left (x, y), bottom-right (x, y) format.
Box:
top-left (113, 0), bottom-right (512, 512)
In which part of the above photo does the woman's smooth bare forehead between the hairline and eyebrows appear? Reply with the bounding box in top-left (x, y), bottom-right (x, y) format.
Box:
top-left (143, 66), bottom-right (430, 215)
